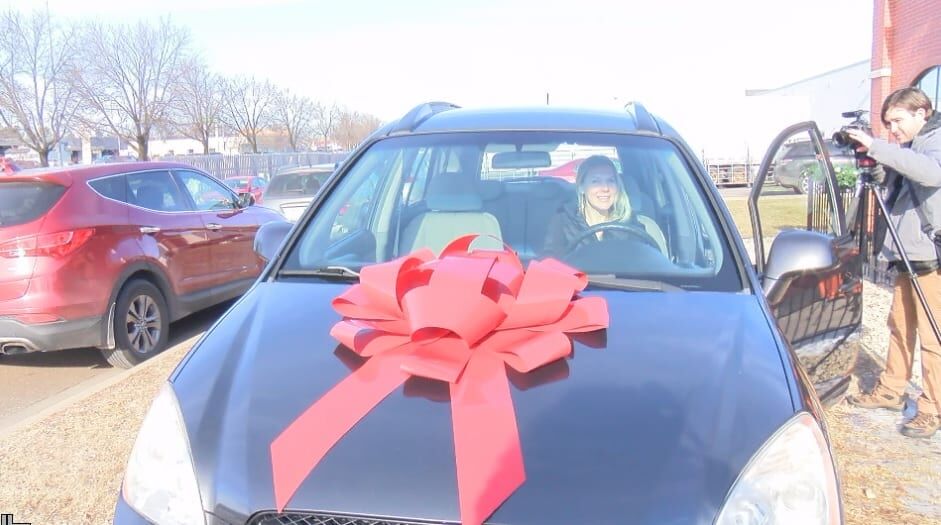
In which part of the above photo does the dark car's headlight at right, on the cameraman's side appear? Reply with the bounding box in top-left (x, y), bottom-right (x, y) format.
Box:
top-left (716, 412), bottom-right (841, 525)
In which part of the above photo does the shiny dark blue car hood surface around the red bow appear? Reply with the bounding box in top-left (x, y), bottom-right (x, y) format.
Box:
top-left (172, 281), bottom-right (795, 524)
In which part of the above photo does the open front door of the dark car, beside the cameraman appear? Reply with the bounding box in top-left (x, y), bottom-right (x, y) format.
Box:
top-left (745, 122), bottom-right (863, 403)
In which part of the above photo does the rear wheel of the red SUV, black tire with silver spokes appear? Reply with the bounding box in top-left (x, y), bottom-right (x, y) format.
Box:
top-left (101, 279), bottom-right (170, 368)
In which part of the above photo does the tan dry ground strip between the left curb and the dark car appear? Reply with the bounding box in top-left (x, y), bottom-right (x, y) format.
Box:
top-left (0, 339), bottom-right (195, 525)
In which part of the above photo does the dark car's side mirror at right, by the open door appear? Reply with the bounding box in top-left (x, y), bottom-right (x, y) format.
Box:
top-left (761, 230), bottom-right (839, 304)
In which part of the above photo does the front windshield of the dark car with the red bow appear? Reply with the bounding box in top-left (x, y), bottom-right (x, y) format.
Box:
top-left (280, 132), bottom-right (743, 290)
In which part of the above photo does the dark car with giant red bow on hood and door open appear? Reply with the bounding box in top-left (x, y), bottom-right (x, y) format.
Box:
top-left (114, 103), bottom-right (862, 525)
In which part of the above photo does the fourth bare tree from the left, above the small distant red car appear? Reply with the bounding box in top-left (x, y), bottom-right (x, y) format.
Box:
top-left (222, 77), bottom-right (278, 153)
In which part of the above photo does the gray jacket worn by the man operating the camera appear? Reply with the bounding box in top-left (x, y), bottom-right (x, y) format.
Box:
top-left (869, 112), bottom-right (941, 261)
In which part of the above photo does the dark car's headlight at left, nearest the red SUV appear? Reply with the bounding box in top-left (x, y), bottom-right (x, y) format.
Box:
top-left (123, 383), bottom-right (206, 525)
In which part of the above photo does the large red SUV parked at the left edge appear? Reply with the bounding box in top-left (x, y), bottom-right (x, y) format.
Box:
top-left (0, 162), bottom-right (280, 368)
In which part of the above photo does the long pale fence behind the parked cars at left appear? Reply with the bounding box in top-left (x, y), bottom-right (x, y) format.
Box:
top-left (160, 152), bottom-right (349, 179)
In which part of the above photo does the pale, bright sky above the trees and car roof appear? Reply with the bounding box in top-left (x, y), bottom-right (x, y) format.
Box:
top-left (0, 0), bottom-right (873, 158)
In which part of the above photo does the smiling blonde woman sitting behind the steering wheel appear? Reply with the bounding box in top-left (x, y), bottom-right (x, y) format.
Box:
top-left (544, 155), bottom-right (666, 257)
